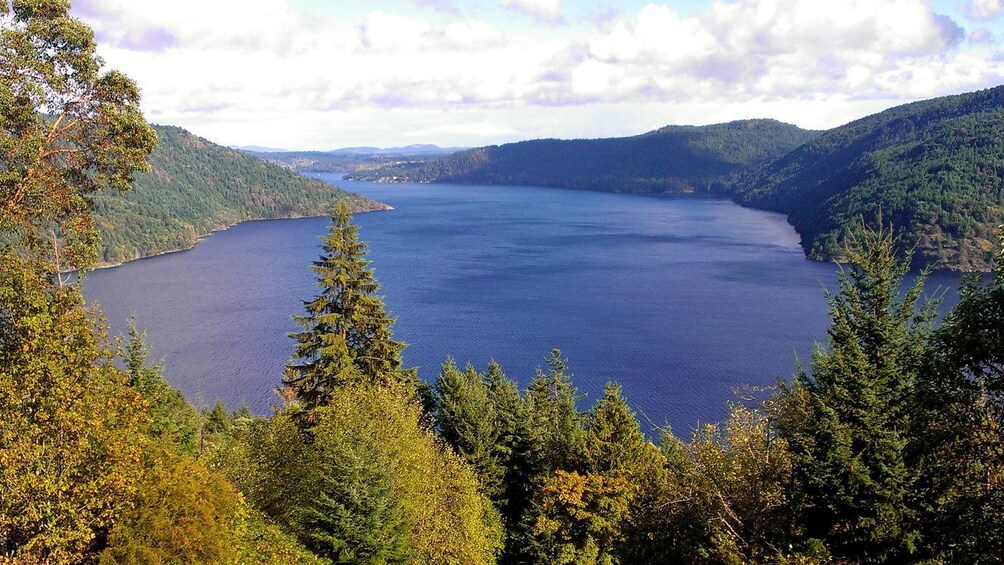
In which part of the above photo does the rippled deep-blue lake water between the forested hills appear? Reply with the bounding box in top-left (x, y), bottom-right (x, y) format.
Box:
top-left (84, 175), bottom-right (958, 433)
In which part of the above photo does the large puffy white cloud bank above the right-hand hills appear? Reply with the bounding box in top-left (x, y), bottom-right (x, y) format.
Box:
top-left (551, 0), bottom-right (965, 102)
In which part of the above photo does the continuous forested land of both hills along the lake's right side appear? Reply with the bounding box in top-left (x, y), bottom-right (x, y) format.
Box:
top-left (347, 86), bottom-right (1004, 271)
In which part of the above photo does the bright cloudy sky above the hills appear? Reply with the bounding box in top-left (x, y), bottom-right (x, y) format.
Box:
top-left (71, 0), bottom-right (1004, 151)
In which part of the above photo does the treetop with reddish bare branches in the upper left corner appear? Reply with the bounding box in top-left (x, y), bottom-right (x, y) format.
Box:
top-left (0, 0), bottom-right (157, 271)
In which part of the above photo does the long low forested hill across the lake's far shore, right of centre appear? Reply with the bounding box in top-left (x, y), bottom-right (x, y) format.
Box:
top-left (348, 119), bottom-right (818, 193)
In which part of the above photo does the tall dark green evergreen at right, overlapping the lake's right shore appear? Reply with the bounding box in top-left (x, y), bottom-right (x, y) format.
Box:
top-left (779, 225), bottom-right (934, 562)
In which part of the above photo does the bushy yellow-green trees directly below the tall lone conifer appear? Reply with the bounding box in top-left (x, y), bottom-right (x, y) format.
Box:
top-left (212, 382), bottom-right (502, 564)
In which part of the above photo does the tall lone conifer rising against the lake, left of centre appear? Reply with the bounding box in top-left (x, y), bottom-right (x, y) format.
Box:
top-left (283, 202), bottom-right (417, 410)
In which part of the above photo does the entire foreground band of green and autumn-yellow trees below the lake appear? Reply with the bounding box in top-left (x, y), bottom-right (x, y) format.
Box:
top-left (0, 0), bottom-right (1004, 564)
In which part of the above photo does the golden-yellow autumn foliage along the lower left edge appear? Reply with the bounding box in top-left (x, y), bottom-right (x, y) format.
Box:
top-left (0, 254), bottom-right (148, 563)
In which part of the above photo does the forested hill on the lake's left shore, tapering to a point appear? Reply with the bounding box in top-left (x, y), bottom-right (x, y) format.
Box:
top-left (93, 125), bottom-right (387, 263)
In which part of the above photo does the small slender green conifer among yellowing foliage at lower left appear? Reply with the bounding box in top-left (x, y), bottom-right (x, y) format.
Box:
top-left (122, 319), bottom-right (203, 456)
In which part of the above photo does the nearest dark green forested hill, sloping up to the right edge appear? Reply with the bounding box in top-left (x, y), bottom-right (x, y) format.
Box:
top-left (735, 86), bottom-right (1004, 270)
